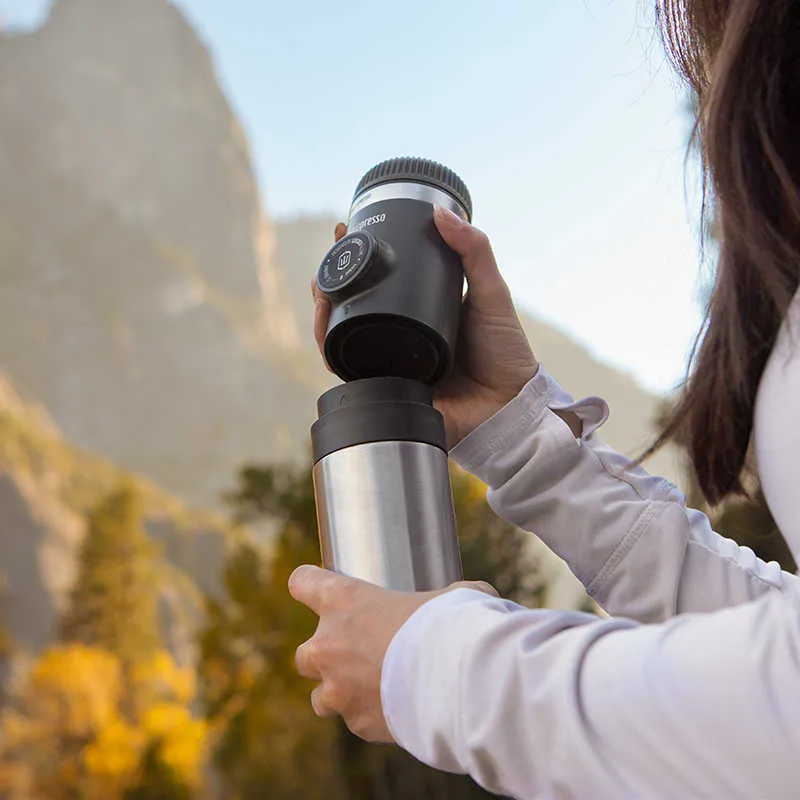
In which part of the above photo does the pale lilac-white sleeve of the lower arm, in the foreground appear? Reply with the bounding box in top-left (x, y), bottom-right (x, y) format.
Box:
top-left (381, 589), bottom-right (800, 800)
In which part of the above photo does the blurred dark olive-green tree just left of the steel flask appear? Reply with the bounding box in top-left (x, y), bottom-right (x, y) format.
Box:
top-left (200, 469), bottom-right (349, 800)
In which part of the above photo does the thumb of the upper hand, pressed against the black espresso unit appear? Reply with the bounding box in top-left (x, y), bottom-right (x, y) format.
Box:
top-left (433, 205), bottom-right (514, 313)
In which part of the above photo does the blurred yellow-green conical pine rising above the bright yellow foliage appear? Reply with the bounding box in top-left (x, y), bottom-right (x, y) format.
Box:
top-left (62, 483), bottom-right (160, 668)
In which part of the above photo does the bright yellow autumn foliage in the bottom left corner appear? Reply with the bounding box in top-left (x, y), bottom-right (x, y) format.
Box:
top-left (0, 644), bottom-right (208, 800)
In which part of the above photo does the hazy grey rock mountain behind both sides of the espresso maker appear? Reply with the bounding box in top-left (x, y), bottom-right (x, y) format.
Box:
top-left (0, 0), bottom-right (671, 506)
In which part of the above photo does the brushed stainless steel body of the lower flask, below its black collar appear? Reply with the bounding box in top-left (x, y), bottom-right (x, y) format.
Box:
top-left (313, 442), bottom-right (461, 591)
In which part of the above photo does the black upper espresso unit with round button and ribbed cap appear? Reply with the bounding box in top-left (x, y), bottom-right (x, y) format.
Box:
top-left (317, 158), bottom-right (472, 384)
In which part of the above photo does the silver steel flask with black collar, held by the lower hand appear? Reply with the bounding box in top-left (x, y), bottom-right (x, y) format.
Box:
top-left (311, 377), bottom-right (461, 591)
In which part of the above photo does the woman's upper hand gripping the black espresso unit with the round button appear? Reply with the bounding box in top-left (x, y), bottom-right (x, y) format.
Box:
top-left (312, 206), bottom-right (539, 447)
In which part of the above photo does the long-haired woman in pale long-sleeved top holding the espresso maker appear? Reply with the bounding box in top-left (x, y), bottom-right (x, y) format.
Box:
top-left (290, 0), bottom-right (800, 800)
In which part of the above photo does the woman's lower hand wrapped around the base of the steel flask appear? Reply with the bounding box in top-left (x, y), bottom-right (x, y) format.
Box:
top-left (289, 565), bottom-right (497, 742)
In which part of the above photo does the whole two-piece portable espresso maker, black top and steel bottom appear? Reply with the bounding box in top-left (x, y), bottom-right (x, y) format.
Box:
top-left (311, 158), bottom-right (472, 591)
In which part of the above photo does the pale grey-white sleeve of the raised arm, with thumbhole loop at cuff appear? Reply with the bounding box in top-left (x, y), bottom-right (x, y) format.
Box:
top-left (451, 367), bottom-right (800, 622)
